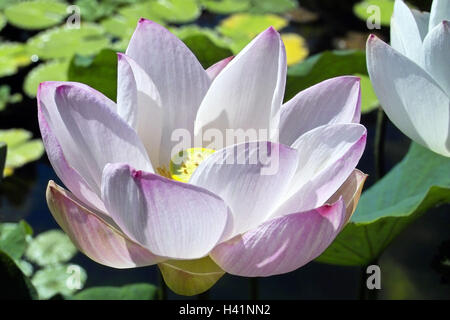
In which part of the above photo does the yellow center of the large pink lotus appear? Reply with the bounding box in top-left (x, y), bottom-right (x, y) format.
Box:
top-left (157, 148), bottom-right (215, 182)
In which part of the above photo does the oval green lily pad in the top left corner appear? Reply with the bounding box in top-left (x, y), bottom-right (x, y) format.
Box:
top-left (5, 0), bottom-right (68, 29)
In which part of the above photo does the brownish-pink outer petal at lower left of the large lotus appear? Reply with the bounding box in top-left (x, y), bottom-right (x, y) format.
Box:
top-left (47, 181), bottom-right (162, 268)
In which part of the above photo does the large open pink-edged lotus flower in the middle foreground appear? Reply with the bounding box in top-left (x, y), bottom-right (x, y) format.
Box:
top-left (37, 19), bottom-right (366, 295)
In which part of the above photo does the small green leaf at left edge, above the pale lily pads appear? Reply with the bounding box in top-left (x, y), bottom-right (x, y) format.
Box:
top-left (0, 221), bottom-right (31, 261)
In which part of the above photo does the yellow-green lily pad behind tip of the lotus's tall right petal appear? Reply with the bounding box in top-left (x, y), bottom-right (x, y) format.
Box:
top-left (217, 13), bottom-right (288, 53)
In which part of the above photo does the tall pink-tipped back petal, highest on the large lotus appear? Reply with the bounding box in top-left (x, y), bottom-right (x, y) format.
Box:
top-left (126, 19), bottom-right (211, 163)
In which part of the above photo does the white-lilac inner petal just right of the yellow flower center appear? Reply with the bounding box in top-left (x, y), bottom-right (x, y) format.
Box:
top-left (189, 142), bottom-right (298, 237)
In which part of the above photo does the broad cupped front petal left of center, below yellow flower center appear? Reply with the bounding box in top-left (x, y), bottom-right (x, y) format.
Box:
top-left (102, 164), bottom-right (229, 259)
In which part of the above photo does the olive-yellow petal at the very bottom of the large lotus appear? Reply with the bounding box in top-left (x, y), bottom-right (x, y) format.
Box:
top-left (158, 257), bottom-right (225, 296)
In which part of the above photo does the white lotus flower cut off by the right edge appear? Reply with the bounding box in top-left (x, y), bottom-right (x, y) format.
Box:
top-left (367, 0), bottom-right (450, 157)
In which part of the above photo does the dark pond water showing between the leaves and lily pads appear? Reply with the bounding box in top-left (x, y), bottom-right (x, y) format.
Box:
top-left (0, 0), bottom-right (450, 299)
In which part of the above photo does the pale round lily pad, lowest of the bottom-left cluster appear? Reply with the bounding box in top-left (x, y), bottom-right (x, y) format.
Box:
top-left (31, 264), bottom-right (87, 300)
